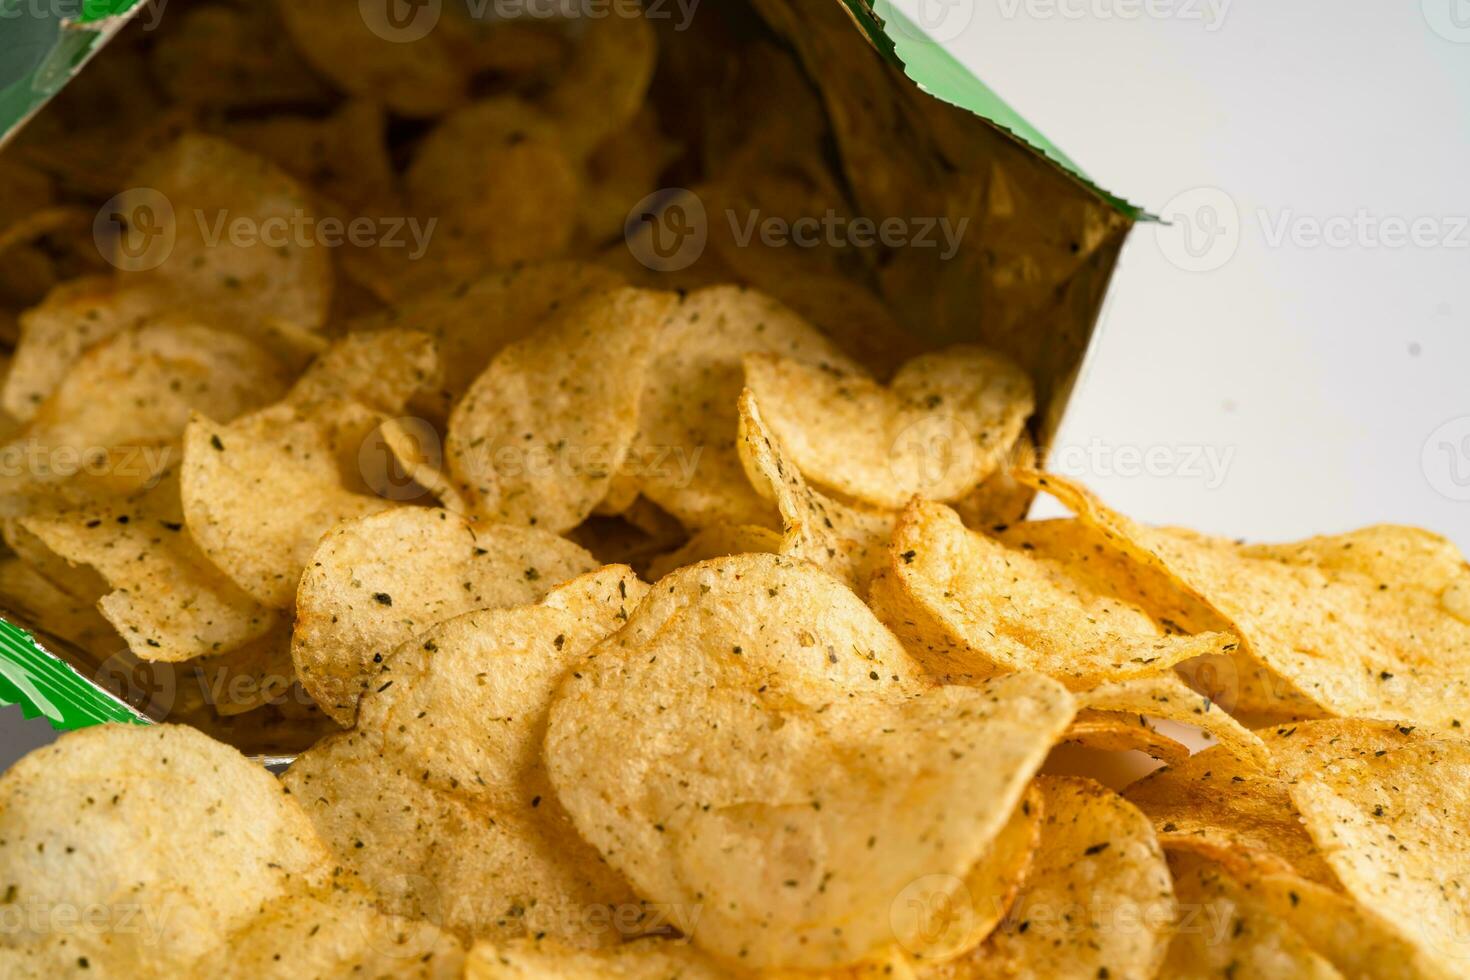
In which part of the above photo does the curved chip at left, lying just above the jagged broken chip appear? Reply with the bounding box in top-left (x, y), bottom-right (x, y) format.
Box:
top-left (0, 323), bottom-right (285, 513)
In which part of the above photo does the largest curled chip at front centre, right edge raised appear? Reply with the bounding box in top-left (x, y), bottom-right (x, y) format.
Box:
top-left (545, 554), bottom-right (1072, 968)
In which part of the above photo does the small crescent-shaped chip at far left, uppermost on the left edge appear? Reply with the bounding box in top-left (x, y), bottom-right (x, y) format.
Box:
top-left (3, 276), bottom-right (166, 420)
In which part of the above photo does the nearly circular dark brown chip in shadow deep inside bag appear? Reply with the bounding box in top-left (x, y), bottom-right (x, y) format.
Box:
top-left (404, 98), bottom-right (585, 272)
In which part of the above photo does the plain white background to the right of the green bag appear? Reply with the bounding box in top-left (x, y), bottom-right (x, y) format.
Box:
top-left (897, 0), bottom-right (1470, 551)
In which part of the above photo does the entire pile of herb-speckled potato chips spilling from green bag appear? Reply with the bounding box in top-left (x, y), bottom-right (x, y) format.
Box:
top-left (0, 0), bottom-right (1470, 980)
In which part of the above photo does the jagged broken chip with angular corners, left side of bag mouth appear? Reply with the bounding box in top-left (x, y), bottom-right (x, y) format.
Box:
top-left (21, 472), bottom-right (275, 663)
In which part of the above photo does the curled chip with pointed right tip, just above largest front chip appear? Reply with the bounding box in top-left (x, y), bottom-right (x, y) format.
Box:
top-left (872, 500), bottom-right (1236, 689)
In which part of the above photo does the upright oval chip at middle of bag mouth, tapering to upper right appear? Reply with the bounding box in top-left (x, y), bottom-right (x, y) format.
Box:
top-left (445, 288), bottom-right (678, 533)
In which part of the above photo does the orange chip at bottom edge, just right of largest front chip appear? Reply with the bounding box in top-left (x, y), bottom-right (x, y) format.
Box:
top-left (925, 776), bottom-right (1177, 980)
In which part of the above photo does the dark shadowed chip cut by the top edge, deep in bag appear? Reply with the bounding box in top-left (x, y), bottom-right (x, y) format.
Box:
top-left (276, 0), bottom-right (469, 116)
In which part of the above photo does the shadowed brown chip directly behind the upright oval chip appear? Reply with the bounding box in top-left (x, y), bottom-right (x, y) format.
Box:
top-left (351, 262), bottom-right (623, 419)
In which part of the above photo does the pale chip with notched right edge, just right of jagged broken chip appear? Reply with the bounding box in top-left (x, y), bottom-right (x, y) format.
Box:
top-left (181, 401), bottom-right (397, 610)
